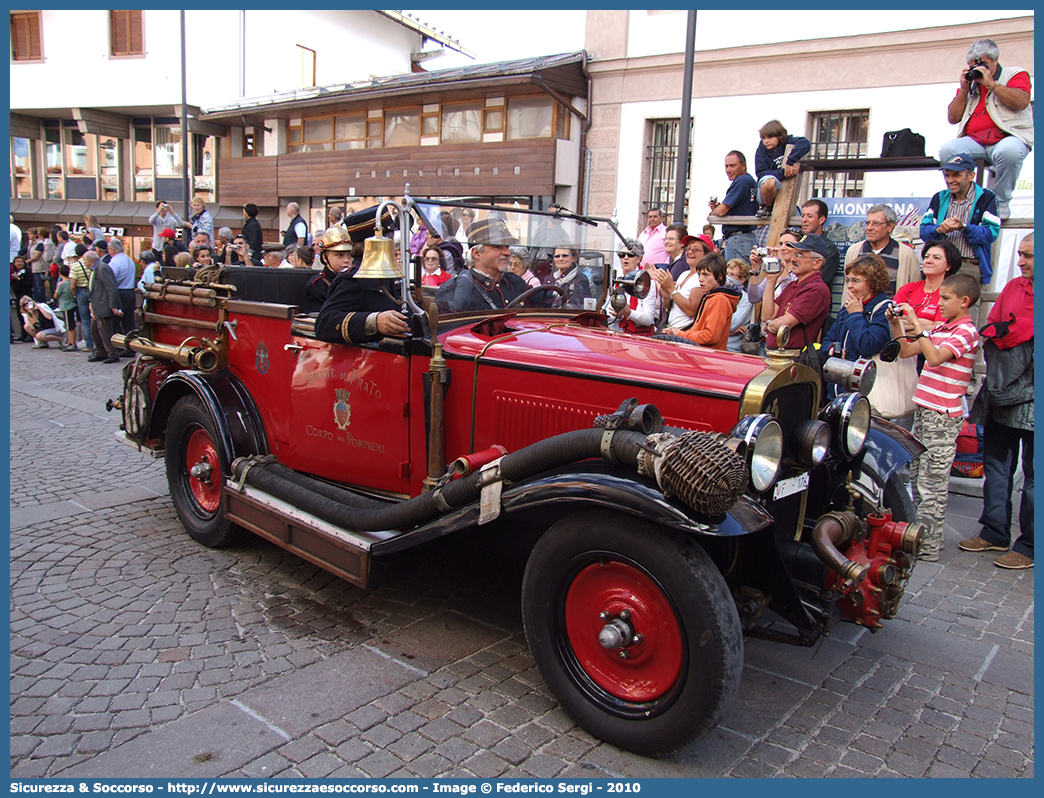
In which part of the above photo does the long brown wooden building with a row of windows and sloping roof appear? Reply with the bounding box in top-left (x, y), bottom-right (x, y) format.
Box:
top-left (196, 52), bottom-right (588, 233)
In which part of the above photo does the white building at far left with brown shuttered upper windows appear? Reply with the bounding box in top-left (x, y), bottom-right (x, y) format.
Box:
top-left (9, 9), bottom-right (466, 240)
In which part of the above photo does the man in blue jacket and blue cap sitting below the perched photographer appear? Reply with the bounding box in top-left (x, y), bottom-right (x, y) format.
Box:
top-left (921, 154), bottom-right (1000, 285)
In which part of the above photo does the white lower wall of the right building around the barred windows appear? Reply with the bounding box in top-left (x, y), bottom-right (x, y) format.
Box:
top-left (616, 81), bottom-right (1034, 232)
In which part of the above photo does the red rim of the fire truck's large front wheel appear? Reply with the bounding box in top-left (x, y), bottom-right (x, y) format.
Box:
top-left (565, 561), bottom-right (684, 703)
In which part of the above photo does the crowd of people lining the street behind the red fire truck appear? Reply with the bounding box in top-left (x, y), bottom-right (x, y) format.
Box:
top-left (10, 40), bottom-right (1034, 568)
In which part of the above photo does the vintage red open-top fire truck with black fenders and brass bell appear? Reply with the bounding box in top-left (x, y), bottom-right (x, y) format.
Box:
top-left (114, 196), bottom-right (923, 755)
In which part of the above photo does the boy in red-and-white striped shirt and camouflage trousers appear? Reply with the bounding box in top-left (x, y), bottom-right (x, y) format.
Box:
top-left (885, 274), bottom-right (979, 562)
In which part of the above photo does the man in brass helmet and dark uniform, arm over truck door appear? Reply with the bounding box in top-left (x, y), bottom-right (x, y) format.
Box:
top-left (313, 206), bottom-right (409, 344)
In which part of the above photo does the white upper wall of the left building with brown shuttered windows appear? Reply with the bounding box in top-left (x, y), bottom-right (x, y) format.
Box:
top-left (10, 9), bottom-right (420, 110)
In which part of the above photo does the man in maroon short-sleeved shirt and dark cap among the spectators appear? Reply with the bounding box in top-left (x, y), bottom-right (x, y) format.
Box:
top-left (761, 234), bottom-right (830, 349)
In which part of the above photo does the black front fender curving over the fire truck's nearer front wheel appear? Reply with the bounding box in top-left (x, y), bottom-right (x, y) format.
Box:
top-left (371, 461), bottom-right (773, 557)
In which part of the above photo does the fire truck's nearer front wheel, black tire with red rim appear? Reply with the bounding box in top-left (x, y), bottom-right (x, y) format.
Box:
top-left (522, 512), bottom-right (743, 756)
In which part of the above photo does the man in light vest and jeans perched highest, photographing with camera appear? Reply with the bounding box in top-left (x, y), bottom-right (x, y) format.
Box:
top-left (939, 39), bottom-right (1034, 219)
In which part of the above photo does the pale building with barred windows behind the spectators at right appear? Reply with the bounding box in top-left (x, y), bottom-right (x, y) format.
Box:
top-left (586, 10), bottom-right (1034, 241)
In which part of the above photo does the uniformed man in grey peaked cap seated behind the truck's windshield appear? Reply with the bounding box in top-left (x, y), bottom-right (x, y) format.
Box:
top-left (435, 217), bottom-right (529, 313)
